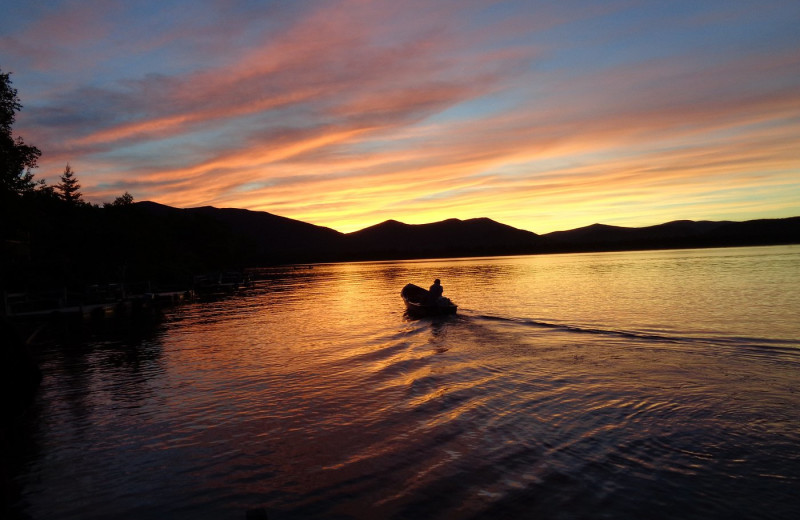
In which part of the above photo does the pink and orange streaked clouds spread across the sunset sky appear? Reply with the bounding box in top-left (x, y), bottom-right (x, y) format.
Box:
top-left (6, 2), bottom-right (800, 233)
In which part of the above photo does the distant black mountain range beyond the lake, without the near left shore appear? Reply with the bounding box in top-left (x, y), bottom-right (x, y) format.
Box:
top-left (134, 201), bottom-right (800, 265)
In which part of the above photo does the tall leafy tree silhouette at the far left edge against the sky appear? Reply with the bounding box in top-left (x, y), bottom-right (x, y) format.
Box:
top-left (0, 70), bottom-right (42, 199)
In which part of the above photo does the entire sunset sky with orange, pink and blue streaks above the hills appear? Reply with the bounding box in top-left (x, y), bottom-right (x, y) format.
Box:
top-left (0, 0), bottom-right (800, 233)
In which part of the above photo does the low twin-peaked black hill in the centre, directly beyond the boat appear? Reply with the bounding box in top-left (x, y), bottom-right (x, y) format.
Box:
top-left (345, 218), bottom-right (543, 258)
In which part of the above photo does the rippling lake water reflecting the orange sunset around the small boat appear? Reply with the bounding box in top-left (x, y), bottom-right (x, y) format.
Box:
top-left (7, 246), bottom-right (800, 520)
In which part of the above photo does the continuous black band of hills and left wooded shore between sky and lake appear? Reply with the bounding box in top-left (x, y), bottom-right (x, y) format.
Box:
top-left (6, 197), bottom-right (800, 294)
